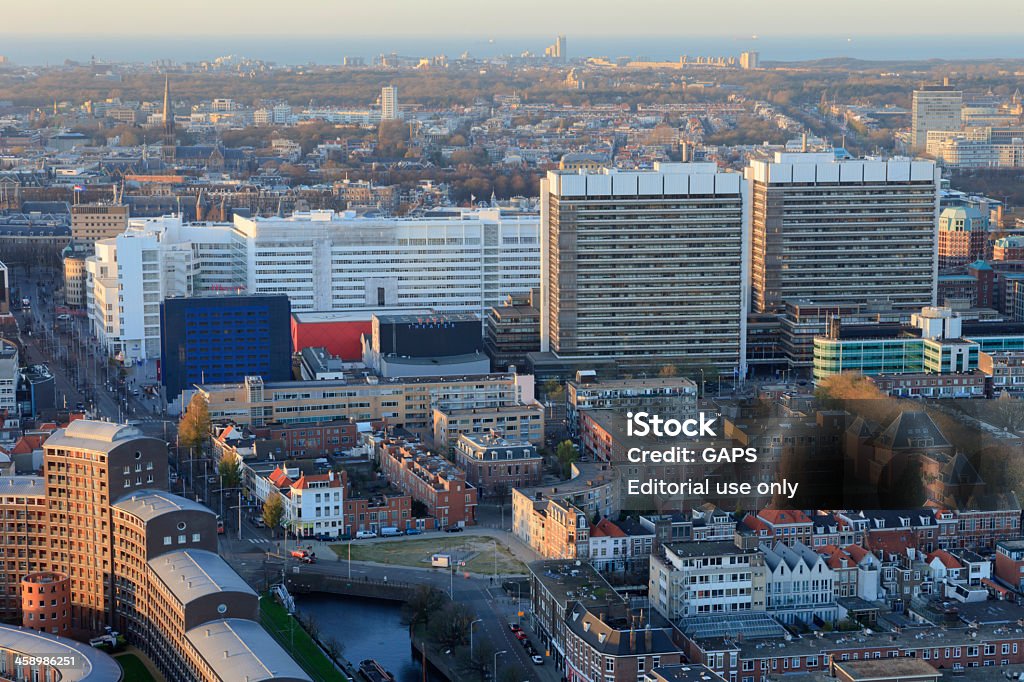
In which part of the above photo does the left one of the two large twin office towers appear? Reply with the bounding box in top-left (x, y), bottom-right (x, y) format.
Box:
top-left (541, 164), bottom-right (748, 372)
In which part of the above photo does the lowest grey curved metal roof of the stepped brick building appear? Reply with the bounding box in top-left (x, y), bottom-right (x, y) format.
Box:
top-left (185, 619), bottom-right (311, 682)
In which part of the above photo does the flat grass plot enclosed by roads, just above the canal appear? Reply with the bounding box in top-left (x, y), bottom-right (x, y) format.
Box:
top-left (331, 535), bottom-right (526, 576)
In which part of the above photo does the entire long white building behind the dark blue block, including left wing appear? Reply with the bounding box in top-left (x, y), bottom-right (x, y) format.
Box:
top-left (86, 209), bottom-right (541, 361)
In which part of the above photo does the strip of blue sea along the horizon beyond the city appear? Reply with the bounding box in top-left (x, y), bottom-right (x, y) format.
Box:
top-left (0, 32), bottom-right (1024, 66)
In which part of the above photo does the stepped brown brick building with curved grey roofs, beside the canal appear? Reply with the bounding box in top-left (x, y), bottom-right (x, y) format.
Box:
top-left (0, 420), bottom-right (309, 682)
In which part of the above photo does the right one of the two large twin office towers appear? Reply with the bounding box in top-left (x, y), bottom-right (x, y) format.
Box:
top-left (746, 152), bottom-right (939, 313)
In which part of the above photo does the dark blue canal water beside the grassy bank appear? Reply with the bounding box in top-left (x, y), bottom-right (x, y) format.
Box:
top-left (295, 594), bottom-right (441, 682)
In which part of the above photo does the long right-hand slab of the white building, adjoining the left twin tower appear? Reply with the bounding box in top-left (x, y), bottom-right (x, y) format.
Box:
top-left (233, 209), bottom-right (541, 318)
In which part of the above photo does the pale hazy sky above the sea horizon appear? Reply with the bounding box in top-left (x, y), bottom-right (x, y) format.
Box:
top-left (8, 0), bottom-right (1024, 36)
